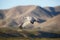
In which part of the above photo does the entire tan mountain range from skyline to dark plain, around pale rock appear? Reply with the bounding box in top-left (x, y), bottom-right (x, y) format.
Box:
top-left (0, 5), bottom-right (60, 36)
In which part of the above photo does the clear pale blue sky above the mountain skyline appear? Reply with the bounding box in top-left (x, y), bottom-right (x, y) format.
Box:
top-left (0, 0), bottom-right (60, 9)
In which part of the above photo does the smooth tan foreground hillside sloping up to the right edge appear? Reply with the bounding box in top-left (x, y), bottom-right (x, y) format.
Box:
top-left (34, 15), bottom-right (60, 33)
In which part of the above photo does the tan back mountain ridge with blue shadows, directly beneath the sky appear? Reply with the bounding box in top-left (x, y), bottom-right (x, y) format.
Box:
top-left (0, 5), bottom-right (60, 32)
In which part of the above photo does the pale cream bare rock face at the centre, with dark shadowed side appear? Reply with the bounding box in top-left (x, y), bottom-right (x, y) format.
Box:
top-left (21, 16), bottom-right (35, 29)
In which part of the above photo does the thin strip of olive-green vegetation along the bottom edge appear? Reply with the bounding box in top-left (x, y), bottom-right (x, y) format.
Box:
top-left (0, 37), bottom-right (60, 40)
